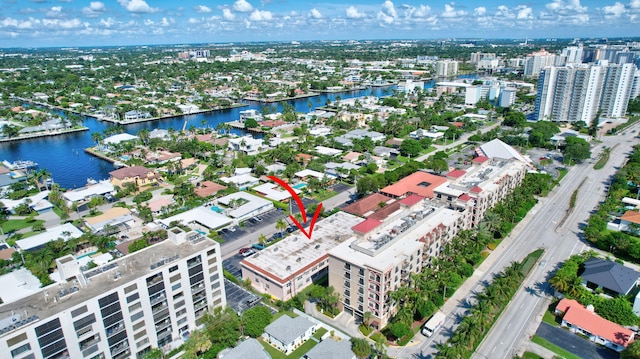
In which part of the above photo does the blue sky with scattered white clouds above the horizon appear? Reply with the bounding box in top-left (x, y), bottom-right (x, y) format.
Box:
top-left (0, 0), bottom-right (640, 47)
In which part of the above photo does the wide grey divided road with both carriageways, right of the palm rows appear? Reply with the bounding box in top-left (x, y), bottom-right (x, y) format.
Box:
top-left (389, 124), bottom-right (638, 359)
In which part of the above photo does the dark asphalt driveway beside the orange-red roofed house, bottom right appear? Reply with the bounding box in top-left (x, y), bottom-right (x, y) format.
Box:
top-left (536, 322), bottom-right (620, 359)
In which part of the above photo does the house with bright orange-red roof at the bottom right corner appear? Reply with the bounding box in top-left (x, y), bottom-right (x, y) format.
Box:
top-left (556, 298), bottom-right (634, 352)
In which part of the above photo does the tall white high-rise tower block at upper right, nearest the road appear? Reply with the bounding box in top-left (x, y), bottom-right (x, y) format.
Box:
top-left (534, 61), bottom-right (636, 124)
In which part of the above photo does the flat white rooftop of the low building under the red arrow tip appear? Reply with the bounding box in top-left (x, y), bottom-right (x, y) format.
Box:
top-left (240, 212), bottom-right (362, 283)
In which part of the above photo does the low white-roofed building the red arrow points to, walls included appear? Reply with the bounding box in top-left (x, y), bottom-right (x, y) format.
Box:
top-left (240, 212), bottom-right (362, 300)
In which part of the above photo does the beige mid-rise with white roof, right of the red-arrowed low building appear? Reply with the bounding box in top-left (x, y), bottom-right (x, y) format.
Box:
top-left (329, 194), bottom-right (462, 328)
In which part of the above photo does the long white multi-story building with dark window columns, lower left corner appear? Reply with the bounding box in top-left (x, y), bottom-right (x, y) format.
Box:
top-left (0, 228), bottom-right (226, 359)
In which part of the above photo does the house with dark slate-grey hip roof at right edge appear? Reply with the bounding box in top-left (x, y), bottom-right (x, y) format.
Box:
top-left (580, 257), bottom-right (640, 295)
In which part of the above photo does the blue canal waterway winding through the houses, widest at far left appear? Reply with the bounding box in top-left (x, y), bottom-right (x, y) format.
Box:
top-left (0, 75), bottom-right (476, 189)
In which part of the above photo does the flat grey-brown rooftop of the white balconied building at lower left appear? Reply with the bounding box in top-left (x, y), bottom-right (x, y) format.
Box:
top-left (0, 236), bottom-right (216, 336)
